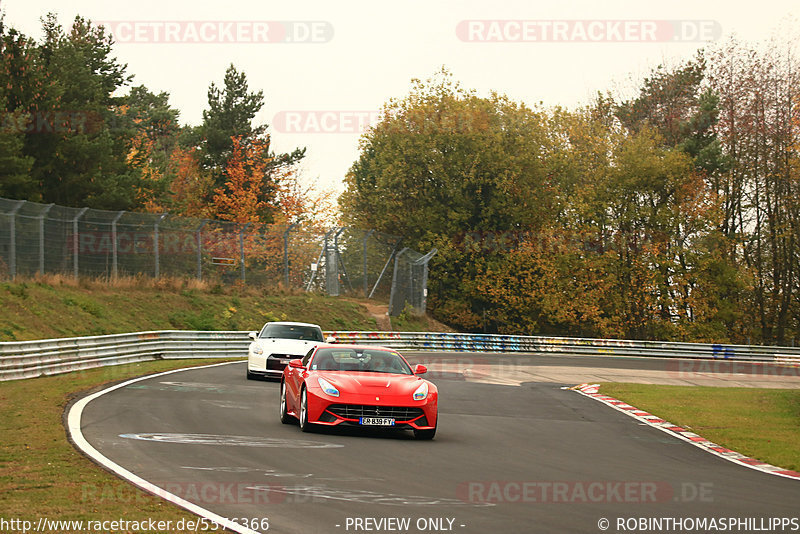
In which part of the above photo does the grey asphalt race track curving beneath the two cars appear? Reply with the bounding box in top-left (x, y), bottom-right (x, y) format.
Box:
top-left (73, 354), bottom-right (800, 534)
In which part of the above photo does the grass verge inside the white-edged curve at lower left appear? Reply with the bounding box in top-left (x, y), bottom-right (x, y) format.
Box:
top-left (0, 360), bottom-right (238, 524)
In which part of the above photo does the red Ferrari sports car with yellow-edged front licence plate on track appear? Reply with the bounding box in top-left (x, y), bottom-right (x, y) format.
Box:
top-left (280, 345), bottom-right (439, 439)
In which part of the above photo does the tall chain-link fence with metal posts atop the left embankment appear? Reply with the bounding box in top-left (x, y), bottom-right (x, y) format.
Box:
top-left (0, 198), bottom-right (434, 313)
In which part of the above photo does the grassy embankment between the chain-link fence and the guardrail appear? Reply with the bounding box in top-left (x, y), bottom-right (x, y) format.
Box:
top-left (0, 276), bottom-right (444, 341)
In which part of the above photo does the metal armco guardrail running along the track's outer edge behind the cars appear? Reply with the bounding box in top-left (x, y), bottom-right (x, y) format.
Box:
top-left (0, 330), bottom-right (800, 381)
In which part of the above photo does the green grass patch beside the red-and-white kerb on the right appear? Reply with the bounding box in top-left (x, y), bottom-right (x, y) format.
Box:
top-left (600, 383), bottom-right (800, 471)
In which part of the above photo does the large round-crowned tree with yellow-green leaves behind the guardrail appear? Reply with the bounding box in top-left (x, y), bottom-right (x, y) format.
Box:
top-left (340, 71), bottom-right (552, 327)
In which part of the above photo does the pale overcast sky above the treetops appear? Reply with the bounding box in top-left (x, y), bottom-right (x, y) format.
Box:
top-left (0, 0), bottom-right (800, 193)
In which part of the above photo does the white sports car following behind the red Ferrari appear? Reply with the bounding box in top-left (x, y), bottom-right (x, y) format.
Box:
top-left (247, 322), bottom-right (333, 380)
